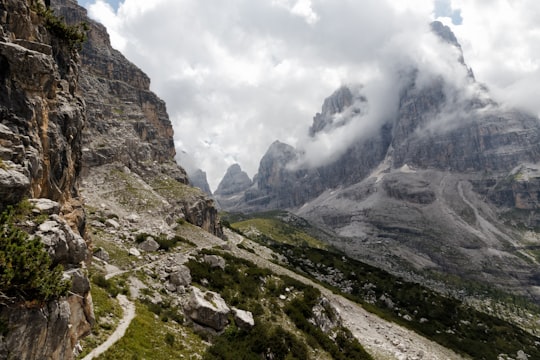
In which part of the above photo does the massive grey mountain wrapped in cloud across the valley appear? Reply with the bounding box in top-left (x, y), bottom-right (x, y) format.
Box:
top-left (218, 23), bottom-right (540, 300)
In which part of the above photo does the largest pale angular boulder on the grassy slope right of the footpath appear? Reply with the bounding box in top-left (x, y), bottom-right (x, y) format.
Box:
top-left (184, 287), bottom-right (231, 331)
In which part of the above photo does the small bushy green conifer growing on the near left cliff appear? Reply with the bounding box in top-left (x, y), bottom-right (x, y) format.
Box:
top-left (0, 207), bottom-right (71, 302)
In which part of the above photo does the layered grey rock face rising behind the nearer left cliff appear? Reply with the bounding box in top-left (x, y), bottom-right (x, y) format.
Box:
top-left (53, 0), bottom-right (223, 237)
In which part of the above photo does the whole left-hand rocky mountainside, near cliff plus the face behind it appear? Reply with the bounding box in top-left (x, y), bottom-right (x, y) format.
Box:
top-left (0, 0), bottom-right (222, 359)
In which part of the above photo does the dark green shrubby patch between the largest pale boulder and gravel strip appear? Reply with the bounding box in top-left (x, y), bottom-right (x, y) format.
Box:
top-left (186, 250), bottom-right (371, 360)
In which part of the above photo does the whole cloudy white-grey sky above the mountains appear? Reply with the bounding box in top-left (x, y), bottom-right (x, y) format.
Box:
top-left (75, 0), bottom-right (540, 190)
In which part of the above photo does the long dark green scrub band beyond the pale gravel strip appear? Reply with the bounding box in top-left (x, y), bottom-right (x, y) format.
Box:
top-left (226, 214), bottom-right (540, 359)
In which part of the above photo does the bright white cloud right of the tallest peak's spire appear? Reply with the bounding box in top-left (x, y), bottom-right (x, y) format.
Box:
top-left (452, 0), bottom-right (540, 115)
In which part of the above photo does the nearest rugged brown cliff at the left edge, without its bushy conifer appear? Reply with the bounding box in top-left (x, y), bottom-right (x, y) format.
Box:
top-left (0, 0), bottom-right (93, 359)
